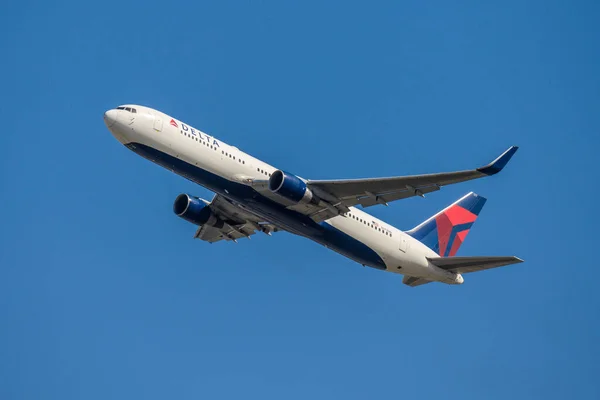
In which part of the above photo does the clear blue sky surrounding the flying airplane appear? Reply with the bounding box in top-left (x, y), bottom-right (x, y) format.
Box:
top-left (0, 0), bottom-right (600, 400)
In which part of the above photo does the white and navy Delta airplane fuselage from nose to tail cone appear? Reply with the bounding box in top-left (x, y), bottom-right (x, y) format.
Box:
top-left (105, 105), bottom-right (462, 284)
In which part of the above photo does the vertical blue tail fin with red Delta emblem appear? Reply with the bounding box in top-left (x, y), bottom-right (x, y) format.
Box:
top-left (406, 192), bottom-right (486, 257)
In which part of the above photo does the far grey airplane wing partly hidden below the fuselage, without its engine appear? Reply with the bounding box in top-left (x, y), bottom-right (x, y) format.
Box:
top-left (194, 195), bottom-right (280, 243)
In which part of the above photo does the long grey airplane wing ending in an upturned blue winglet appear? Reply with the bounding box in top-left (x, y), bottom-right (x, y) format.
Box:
top-left (307, 146), bottom-right (518, 216)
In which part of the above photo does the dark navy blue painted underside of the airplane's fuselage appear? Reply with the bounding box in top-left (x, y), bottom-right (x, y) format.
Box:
top-left (126, 143), bottom-right (386, 269)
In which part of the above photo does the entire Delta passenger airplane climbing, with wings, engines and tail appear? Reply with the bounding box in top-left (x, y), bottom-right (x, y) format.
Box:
top-left (104, 104), bottom-right (523, 287)
